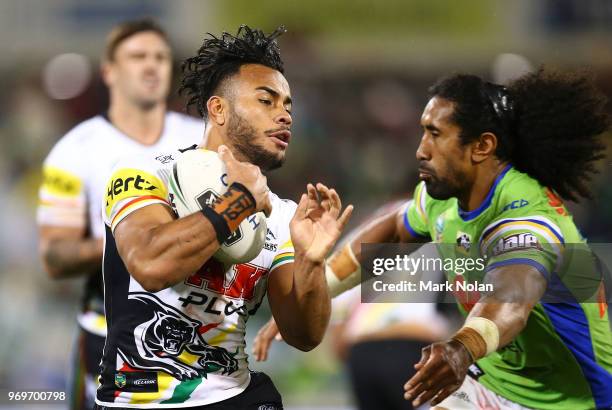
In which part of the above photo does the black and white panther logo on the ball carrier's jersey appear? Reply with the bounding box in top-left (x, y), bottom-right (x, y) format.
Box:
top-left (118, 292), bottom-right (238, 380)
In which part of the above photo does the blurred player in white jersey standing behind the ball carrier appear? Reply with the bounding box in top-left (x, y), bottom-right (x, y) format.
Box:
top-left (37, 19), bottom-right (204, 409)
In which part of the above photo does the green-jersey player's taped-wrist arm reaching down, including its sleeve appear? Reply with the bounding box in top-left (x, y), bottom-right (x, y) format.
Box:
top-left (404, 211), bottom-right (567, 407)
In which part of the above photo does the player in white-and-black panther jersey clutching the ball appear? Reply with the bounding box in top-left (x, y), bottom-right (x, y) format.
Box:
top-left (96, 26), bottom-right (352, 410)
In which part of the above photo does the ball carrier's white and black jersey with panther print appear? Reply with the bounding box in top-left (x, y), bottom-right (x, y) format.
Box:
top-left (96, 152), bottom-right (297, 408)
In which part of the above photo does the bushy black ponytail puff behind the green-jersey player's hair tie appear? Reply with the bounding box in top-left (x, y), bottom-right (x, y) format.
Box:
top-left (508, 68), bottom-right (610, 201)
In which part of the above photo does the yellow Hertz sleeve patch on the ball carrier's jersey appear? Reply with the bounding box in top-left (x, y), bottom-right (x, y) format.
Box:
top-left (106, 168), bottom-right (168, 215)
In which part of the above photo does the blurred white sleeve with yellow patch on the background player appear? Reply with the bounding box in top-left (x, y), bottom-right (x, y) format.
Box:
top-left (36, 137), bottom-right (87, 228)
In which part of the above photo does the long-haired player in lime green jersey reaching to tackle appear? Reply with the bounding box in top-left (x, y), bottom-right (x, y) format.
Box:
top-left (322, 70), bottom-right (612, 410)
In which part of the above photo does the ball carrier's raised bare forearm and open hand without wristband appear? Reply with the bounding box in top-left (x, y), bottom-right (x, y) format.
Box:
top-left (268, 184), bottom-right (353, 351)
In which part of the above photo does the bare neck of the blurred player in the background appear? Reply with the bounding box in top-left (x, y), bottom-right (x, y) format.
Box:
top-left (108, 103), bottom-right (166, 145)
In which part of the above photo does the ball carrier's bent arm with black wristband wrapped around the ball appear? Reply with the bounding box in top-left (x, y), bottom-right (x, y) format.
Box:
top-left (111, 146), bottom-right (271, 292)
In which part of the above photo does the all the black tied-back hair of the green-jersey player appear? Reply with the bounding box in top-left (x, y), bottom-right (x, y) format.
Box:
top-left (429, 68), bottom-right (610, 201)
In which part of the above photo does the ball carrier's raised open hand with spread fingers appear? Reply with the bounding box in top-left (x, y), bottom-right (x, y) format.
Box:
top-left (289, 183), bottom-right (353, 261)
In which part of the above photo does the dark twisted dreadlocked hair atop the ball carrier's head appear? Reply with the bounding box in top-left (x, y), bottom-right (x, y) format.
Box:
top-left (179, 24), bottom-right (286, 118)
